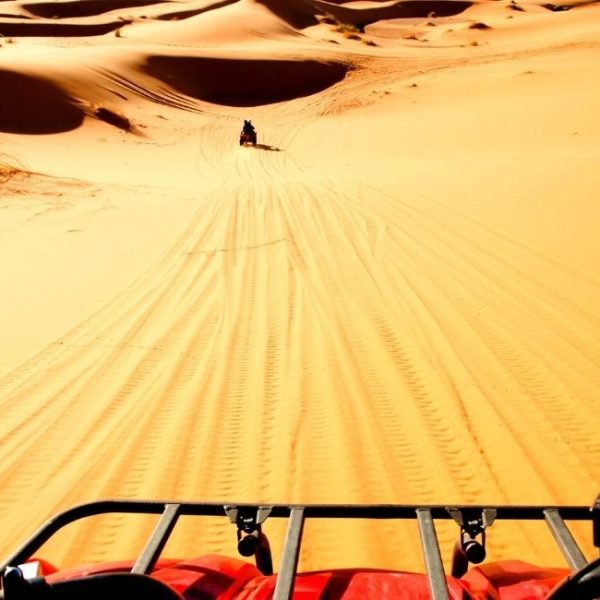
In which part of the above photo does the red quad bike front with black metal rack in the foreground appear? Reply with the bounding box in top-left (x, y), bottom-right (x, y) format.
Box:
top-left (0, 496), bottom-right (600, 600)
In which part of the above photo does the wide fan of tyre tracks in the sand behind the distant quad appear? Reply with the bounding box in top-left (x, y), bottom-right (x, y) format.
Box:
top-left (0, 84), bottom-right (600, 568)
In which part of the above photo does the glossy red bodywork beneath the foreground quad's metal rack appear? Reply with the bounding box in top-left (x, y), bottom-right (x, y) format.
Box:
top-left (43, 555), bottom-right (569, 600)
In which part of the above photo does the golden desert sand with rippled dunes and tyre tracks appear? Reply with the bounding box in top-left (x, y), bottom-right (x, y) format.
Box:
top-left (0, 0), bottom-right (600, 569)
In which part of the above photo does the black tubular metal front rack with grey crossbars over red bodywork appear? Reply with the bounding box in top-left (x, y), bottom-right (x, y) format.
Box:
top-left (0, 497), bottom-right (600, 600)
